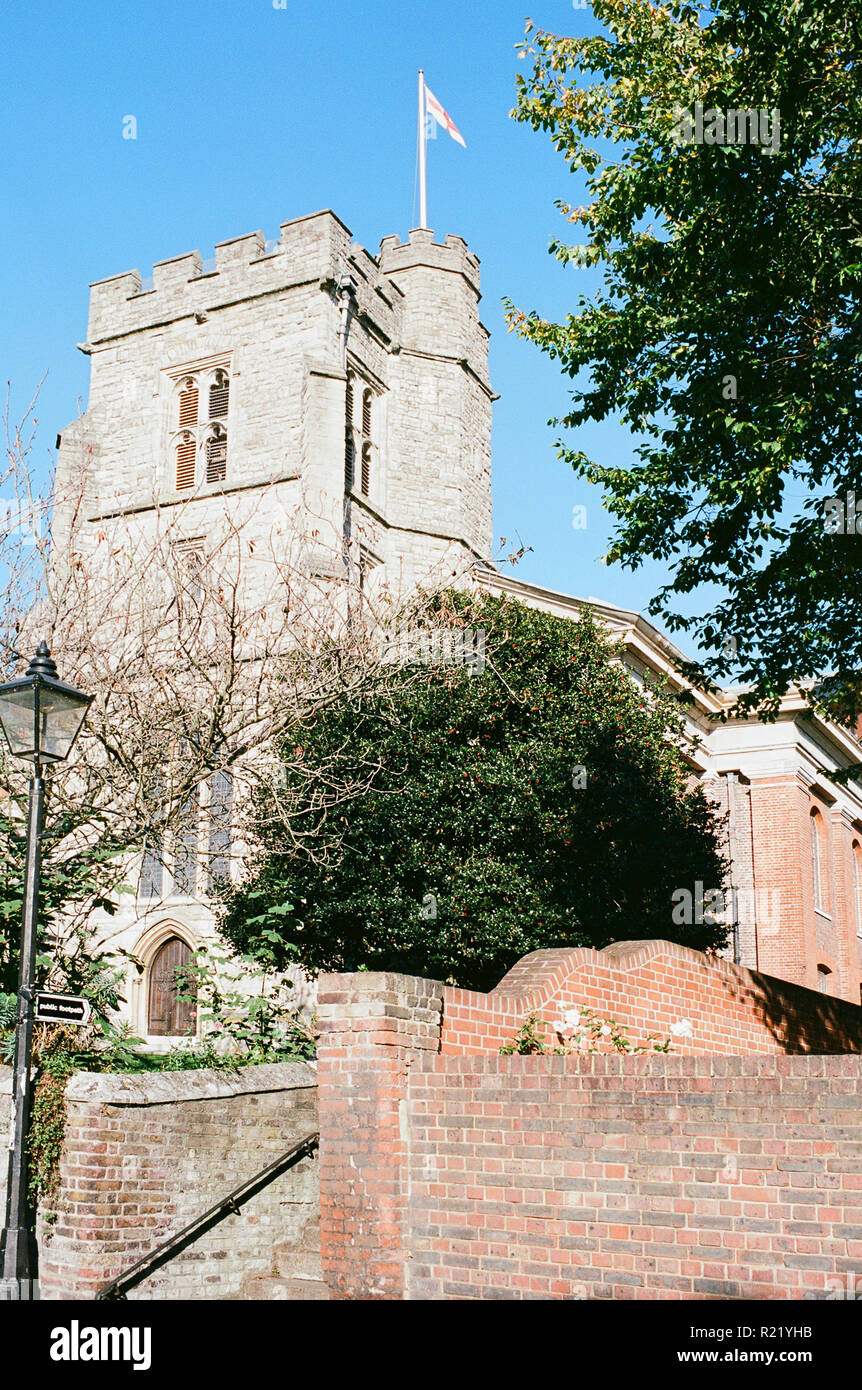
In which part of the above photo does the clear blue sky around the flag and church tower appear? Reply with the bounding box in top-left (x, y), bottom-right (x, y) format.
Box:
top-left (0, 0), bottom-right (686, 636)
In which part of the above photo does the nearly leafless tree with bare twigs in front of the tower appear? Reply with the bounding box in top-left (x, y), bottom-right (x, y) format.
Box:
top-left (0, 393), bottom-right (458, 1030)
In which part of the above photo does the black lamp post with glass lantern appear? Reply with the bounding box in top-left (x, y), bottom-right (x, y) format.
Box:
top-left (0, 642), bottom-right (93, 1298)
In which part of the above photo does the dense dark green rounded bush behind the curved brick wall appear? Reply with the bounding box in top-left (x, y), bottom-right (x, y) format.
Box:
top-left (222, 598), bottom-right (724, 988)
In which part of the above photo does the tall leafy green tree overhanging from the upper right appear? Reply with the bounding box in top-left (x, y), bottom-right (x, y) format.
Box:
top-left (507, 0), bottom-right (862, 739)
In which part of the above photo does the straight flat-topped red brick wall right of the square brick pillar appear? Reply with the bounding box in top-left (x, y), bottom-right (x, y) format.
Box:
top-left (405, 1055), bottom-right (862, 1300)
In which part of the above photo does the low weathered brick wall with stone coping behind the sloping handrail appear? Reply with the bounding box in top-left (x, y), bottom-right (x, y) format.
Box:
top-left (24, 1063), bottom-right (318, 1298)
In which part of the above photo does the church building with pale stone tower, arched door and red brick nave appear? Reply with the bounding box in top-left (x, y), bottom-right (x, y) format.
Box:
top-left (54, 211), bottom-right (862, 1045)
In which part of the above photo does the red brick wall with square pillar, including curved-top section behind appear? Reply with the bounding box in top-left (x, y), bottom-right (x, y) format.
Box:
top-left (318, 942), bottom-right (862, 1298)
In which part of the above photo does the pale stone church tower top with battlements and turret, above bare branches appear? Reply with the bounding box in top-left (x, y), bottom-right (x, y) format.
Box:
top-left (54, 211), bottom-right (494, 588)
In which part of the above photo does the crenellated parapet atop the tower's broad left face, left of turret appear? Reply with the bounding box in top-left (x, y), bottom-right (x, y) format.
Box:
top-left (88, 210), bottom-right (350, 346)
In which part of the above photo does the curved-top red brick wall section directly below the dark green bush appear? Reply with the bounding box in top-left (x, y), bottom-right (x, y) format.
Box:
top-left (441, 941), bottom-right (862, 1055)
